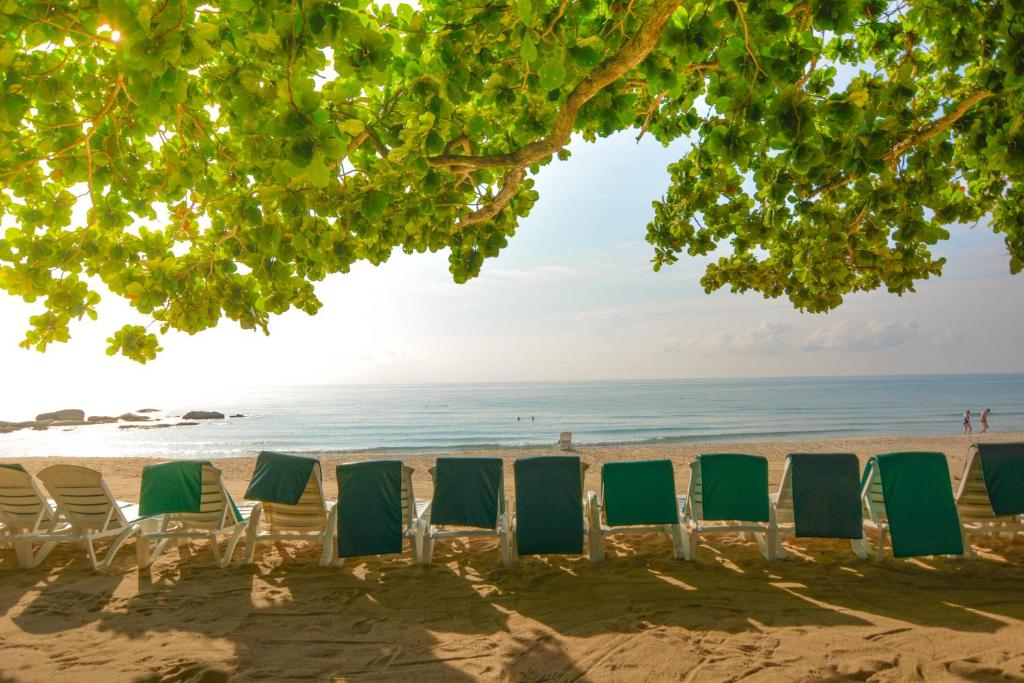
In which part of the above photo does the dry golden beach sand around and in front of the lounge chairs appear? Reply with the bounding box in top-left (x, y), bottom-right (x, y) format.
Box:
top-left (0, 434), bottom-right (1024, 681)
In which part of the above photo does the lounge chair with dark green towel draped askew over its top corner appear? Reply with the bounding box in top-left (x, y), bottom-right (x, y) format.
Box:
top-left (242, 451), bottom-right (331, 564)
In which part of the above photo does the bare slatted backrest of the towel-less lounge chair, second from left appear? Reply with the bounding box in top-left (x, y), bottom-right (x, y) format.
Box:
top-left (38, 465), bottom-right (128, 532)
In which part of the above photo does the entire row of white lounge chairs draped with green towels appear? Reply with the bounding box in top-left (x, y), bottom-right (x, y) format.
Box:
top-left (0, 443), bottom-right (1024, 569)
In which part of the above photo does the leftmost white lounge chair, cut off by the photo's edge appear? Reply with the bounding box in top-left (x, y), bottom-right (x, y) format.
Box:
top-left (0, 465), bottom-right (69, 569)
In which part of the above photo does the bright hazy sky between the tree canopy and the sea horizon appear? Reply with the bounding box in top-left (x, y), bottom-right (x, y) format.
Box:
top-left (0, 127), bottom-right (1024, 419)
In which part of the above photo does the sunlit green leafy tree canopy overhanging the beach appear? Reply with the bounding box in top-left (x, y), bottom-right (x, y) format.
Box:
top-left (0, 0), bottom-right (1024, 361)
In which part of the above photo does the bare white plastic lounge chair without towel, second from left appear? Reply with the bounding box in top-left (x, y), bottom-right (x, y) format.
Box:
top-left (30, 465), bottom-right (138, 569)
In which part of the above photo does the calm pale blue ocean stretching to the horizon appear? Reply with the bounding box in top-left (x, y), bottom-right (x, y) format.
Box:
top-left (0, 374), bottom-right (1024, 459)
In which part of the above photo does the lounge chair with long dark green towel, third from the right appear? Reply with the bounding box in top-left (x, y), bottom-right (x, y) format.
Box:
top-left (772, 453), bottom-right (870, 559)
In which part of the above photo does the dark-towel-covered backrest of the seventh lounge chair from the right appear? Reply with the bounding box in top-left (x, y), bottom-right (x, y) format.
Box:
top-left (430, 457), bottom-right (505, 529)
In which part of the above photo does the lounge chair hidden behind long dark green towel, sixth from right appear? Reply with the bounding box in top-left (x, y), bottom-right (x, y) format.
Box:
top-left (512, 456), bottom-right (586, 562)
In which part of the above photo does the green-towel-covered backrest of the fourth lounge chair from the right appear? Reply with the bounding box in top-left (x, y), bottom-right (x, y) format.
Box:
top-left (688, 453), bottom-right (771, 522)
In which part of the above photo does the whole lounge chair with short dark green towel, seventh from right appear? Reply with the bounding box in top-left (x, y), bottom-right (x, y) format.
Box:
top-left (419, 458), bottom-right (512, 566)
